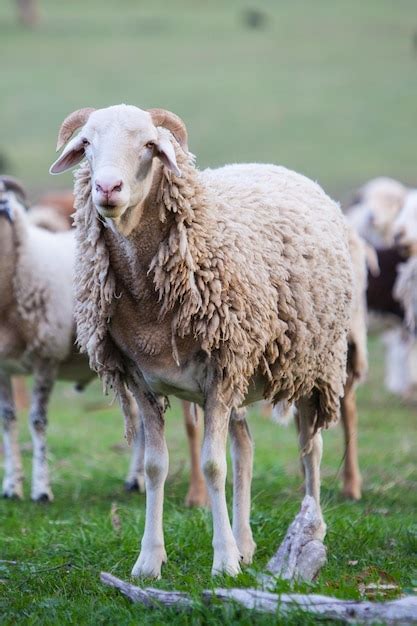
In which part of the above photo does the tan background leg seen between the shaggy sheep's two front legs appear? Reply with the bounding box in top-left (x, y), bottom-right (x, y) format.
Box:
top-left (182, 402), bottom-right (207, 506)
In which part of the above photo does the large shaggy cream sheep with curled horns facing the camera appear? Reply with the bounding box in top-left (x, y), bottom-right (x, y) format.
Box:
top-left (51, 105), bottom-right (352, 576)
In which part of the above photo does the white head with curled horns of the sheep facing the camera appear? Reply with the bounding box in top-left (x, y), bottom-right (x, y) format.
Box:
top-left (50, 104), bottom-right (188, 219)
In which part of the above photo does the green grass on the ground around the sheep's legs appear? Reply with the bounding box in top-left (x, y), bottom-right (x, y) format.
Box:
top-left (0, 334), bottom-right (417, 624)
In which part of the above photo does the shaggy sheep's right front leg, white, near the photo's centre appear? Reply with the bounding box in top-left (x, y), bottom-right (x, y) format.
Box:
top-left (202, 394), bottom-right (241, 576)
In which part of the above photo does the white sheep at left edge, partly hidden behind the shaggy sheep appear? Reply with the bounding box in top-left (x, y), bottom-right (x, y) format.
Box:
top-left (0, 176), bottom-right (143, 500)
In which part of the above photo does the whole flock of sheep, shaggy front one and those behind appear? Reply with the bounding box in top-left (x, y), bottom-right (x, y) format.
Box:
top-left (0, 105), bottom-right (417, 577)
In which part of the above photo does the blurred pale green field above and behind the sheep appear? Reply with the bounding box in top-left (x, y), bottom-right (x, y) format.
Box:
top-left (0, 0), bottom-right (417, 199)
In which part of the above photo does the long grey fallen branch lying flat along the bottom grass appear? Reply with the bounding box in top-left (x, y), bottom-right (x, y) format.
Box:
top-left (100, 572), bottom-right (417, 626)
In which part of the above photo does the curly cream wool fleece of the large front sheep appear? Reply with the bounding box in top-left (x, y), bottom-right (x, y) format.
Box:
top-left (75, 141), bottom-right (352, 427)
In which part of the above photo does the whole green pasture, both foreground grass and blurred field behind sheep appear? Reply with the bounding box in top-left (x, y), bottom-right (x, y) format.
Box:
top-left (0, 0), bottom-right (417, 624)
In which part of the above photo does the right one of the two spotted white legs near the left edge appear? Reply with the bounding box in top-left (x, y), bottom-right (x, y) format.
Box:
top-left (29, 361), bottom-right (57, 502)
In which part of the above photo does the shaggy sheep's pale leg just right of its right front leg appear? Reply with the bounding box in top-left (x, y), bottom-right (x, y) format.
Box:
top-left (229, 410), bottom-right (256, 565)
